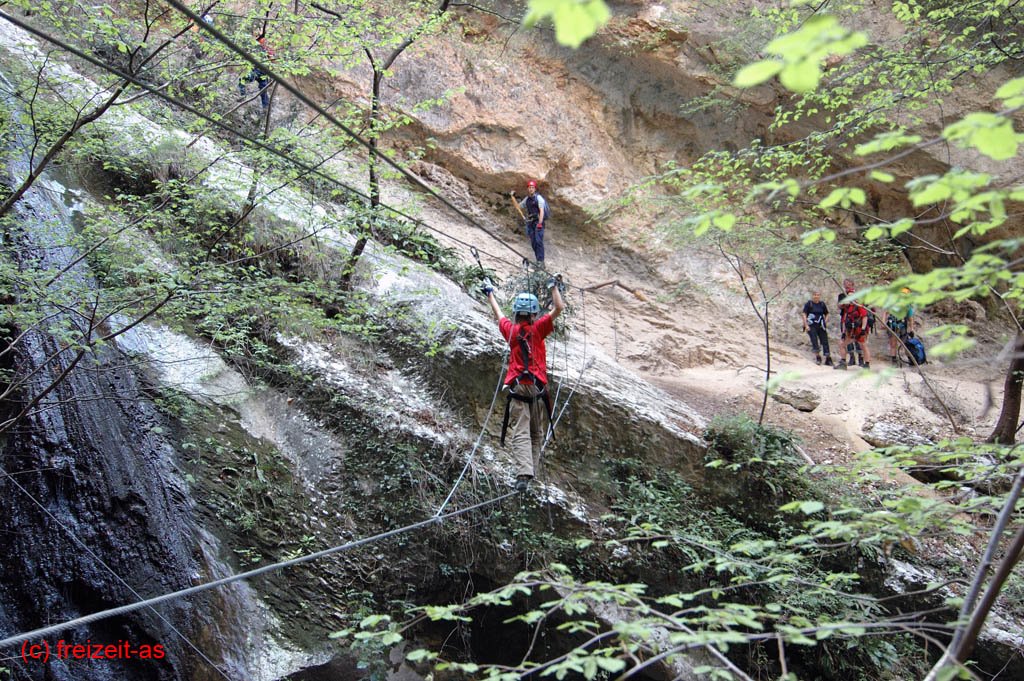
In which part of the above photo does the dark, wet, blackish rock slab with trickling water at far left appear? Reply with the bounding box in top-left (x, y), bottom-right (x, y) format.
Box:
top-left (0, 167), bottom-right (205, 681)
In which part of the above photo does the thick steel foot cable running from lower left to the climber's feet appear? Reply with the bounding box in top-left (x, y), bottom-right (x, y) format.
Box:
top-left (0, 492), bottom-right (518, 648)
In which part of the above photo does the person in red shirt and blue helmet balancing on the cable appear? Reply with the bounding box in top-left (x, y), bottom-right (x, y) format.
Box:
top-left (482, 274), bottom-right (565, 492)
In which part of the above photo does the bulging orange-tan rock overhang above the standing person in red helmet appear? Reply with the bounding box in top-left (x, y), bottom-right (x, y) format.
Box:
top-left (299, 2), bottom-right (774, 229)
